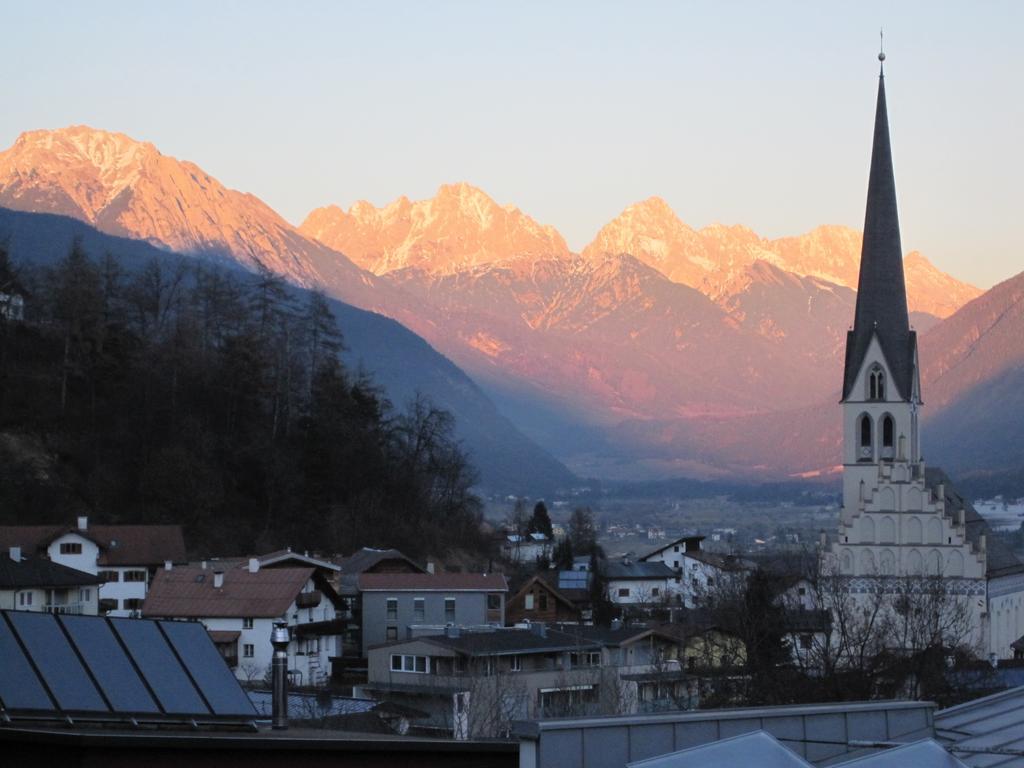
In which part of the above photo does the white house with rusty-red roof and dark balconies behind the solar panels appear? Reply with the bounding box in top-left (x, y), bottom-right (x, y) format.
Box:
top-left (142, 558), bottom-right (343, 685)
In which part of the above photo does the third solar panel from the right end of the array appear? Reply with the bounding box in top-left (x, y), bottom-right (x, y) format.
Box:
top-left (60, 615), bottom-right (160, 714)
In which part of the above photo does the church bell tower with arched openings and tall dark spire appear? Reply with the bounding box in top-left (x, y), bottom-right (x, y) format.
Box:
top-left (842, 53), bottom-right (922, 521)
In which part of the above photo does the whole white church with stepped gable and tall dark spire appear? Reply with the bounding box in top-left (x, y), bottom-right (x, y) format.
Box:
top-left (830, 54), bottom-right (1024, 658)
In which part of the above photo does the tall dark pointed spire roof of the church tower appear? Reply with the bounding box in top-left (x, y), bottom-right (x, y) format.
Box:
top-left (843, 61), bottom-right (916, 399)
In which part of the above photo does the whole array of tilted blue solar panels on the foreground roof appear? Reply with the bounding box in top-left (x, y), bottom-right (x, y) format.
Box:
top-left (0, 610), bottom-right (256, 723)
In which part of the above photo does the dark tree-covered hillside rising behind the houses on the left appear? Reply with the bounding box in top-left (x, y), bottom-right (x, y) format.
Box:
top-left (0, 243), bottom-right (480, 556)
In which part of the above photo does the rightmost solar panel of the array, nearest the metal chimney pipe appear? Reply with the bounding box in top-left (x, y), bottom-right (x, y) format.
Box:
top-left (160, 622), bottom-right (256, 717)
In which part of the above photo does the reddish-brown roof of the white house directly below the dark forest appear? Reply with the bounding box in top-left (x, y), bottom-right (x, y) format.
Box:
top-left (0, 524), bottom-right (185, 565)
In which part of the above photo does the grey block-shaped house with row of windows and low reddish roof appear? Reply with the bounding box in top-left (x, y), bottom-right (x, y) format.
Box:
top-left (358, 573), bottom-right (509, 655)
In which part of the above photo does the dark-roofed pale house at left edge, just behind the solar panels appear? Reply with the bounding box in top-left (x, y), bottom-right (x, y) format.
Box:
top-left (0, 547), bottom-right (101, 616)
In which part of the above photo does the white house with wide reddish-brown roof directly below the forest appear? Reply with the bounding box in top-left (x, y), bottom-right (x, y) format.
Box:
top-left (0, 516), bottom-right (185, 616)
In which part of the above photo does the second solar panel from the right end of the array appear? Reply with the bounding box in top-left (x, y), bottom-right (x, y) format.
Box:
top-left (110, 618), bottom-right (210, 715)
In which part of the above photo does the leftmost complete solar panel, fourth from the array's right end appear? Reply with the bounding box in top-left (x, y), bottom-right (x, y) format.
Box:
top-left (7, 611), bottom-right (110, 712)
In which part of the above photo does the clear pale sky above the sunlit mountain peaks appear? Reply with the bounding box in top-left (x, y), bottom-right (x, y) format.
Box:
top-left (0, 0), bottom-right (1024, 288)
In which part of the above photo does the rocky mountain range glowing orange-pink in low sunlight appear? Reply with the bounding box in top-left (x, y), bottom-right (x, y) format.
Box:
top-left (0, 126), bottom-right (1024, 487)
